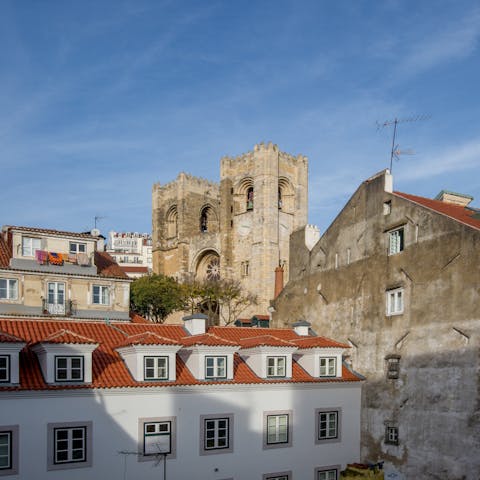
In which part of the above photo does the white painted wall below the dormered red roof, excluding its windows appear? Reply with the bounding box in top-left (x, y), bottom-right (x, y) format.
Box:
top-left (0, 383), bottom-right (361, 480)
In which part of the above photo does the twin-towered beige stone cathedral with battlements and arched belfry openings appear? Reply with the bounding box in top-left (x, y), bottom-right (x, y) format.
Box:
top-left (152, 143), bottom-right (308, 316)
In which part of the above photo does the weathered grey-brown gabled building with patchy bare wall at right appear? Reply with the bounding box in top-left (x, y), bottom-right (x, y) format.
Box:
top-left (273, 171), bottom-right (480, 480)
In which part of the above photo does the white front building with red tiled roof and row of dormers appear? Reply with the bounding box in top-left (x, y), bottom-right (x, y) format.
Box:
top-left (0, 318), bottom-right (363, 480)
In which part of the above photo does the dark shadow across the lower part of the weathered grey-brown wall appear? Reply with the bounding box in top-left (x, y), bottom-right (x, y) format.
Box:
top-left (362, 346), bottom-right (480, 480)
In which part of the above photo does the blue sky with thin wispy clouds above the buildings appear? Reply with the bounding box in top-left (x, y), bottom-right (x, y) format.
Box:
top-left (0, 0), bottom-right (480, 233)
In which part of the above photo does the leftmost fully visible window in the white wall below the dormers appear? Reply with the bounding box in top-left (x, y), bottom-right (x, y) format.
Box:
top-left (53, 427), bottom-right (87, 464)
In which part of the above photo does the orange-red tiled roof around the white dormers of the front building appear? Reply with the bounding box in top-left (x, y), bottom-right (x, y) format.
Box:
top-left (0, 319), bottom-right (362, 390)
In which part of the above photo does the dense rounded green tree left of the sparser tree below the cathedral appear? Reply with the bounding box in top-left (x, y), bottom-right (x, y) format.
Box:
top-left (130, 274), bottom-right (184, 323)
